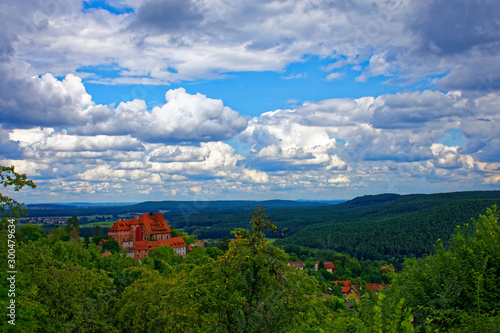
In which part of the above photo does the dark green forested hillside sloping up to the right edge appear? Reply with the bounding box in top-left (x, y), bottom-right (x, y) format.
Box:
top-left (280, 191), bottom-right (500, 259)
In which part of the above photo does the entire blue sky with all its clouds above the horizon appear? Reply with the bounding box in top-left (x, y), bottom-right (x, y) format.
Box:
top-left (0, 0), bottom-right (500, 203)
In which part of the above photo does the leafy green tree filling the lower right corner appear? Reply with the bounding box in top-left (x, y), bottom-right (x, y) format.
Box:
top-left (393, 206), bottom-right (500, 331)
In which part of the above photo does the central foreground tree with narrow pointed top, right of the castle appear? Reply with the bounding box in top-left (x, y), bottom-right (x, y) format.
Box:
top-left (178, 206), bottom-right (323, 332)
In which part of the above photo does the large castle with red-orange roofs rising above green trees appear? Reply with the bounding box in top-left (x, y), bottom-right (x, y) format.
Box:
top-left (108, 213), bottom-right (190, 259)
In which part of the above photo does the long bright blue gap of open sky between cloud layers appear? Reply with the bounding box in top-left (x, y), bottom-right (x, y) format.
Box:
top-left (85, 56), bottom-right (410, 117)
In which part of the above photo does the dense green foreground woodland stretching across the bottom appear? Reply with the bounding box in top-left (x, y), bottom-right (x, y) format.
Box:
top-left (0, 170), bottom-right (500, 332)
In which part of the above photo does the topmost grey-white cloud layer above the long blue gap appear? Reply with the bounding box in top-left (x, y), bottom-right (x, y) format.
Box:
top-left (0, 0), bottom-right (500, 92)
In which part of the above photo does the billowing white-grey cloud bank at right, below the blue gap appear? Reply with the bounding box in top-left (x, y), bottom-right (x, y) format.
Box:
top-left (237, 91), bottom-right (499, 182)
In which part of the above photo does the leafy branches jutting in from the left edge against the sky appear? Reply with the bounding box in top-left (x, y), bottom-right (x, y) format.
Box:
top-left (0, 166), bottom-right (36, 229)
